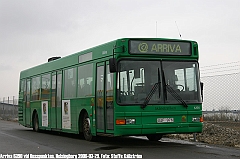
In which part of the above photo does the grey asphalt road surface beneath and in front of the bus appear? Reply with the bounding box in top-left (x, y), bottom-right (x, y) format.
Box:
top-left (0, 120), bottom-right (240, 159)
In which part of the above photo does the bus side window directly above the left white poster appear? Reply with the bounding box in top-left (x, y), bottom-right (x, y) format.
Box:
top-left (41, 74), bottom-right (50, 99)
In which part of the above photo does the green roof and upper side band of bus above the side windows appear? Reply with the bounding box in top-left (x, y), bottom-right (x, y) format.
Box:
top-left (20, 38), bottom-right (197, 79)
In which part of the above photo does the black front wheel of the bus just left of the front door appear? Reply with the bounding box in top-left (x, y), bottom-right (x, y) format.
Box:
top-left (82, 113), bottom-right (96, 141)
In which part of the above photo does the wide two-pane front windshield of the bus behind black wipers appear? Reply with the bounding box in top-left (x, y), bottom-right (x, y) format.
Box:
top-left (117, 60), bottom-right (201, 105)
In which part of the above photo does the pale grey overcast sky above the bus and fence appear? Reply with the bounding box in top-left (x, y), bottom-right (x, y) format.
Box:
top-left (0, 0), bottom-right (240, 100)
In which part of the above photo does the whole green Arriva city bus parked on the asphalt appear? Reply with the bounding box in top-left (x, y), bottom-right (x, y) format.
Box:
top-left (18, 38), bottom-right (203, 141)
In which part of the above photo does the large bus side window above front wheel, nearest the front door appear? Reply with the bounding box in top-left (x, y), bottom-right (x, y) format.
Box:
top-left (78, 64), bottom-right (93, 97)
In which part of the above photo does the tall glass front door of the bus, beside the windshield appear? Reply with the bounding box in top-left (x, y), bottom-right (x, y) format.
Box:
top-left (95, 61), bottom-right (114, 134)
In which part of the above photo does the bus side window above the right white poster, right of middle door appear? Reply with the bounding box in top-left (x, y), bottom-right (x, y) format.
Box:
top-left (64, 68), bottom-right (76, 98)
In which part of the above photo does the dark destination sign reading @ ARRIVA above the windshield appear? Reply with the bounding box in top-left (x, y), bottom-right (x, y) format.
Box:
top-left (129, 40), bottom-right (191, 55)
